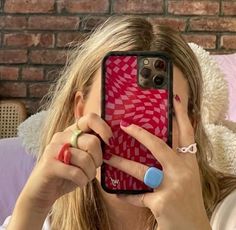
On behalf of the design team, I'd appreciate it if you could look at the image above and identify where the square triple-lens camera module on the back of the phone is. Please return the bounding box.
[138,57,167,89]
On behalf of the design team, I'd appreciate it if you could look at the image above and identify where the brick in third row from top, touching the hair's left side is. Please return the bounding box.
[57,32,86,47]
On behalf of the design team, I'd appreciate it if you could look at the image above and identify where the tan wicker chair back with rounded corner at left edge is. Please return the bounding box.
[0,100,27,138]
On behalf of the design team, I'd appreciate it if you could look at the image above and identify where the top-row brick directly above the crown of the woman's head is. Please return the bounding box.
[113,0,163,13]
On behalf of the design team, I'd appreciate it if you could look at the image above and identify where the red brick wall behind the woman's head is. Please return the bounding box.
[0,0,236,114]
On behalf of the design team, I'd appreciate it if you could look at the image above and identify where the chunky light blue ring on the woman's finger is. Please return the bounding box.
[144,167,163,188]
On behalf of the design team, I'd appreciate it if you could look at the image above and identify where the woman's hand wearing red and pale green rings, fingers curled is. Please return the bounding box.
[14,114,112,214]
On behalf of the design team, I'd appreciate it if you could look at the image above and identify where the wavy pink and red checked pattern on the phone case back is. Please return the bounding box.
[104,56,168,190]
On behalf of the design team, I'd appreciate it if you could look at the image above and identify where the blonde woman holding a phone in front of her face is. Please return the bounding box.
[3,17,236,230]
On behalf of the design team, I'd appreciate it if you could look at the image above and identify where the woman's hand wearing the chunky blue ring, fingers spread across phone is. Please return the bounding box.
[105,97,211,230]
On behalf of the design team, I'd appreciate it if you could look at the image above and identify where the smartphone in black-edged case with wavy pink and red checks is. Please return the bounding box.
[101,51,173,194]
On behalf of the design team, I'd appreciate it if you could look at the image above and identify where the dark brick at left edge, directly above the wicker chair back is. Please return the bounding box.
[0,82,26,97]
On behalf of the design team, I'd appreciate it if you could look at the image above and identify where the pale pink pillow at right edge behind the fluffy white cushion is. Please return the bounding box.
[212,53,236,121]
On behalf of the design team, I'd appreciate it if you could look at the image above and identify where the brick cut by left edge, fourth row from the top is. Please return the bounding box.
[0,50,27,64]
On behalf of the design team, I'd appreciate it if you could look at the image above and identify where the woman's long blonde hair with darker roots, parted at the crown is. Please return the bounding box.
[39,16,236,230]
